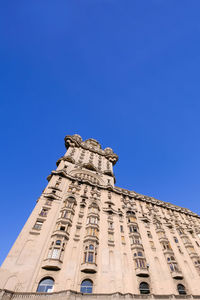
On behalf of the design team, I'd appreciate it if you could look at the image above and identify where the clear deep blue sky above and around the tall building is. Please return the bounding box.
[0,0,200,262]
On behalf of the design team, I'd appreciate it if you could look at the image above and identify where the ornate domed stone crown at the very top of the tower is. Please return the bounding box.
[65,134,118,165]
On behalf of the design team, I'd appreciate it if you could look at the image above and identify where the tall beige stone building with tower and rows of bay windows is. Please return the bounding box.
[0,134,200,300]
